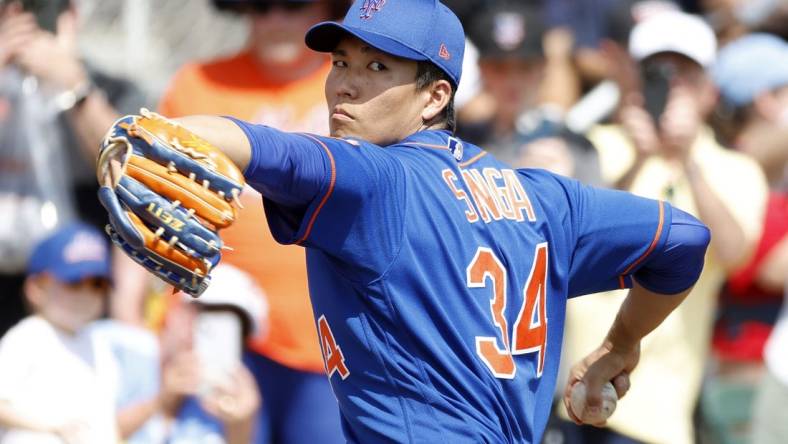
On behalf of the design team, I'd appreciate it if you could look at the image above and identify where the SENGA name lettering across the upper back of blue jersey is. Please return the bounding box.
[441,168,536,223]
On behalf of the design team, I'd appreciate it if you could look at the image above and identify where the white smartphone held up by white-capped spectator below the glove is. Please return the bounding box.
[194,310,243,394]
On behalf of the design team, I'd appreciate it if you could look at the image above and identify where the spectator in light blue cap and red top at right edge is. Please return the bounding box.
[713,34,788,365]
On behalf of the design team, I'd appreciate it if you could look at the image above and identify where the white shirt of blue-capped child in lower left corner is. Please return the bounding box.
[0,316,118,444]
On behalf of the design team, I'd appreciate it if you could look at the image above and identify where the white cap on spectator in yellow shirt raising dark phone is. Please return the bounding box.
[629,11,717,68]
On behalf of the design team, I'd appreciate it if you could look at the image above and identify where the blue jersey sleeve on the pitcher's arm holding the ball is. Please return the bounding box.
[521,170,708,297]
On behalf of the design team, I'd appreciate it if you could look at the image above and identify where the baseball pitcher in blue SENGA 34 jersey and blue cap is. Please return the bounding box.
[101,0,709,443]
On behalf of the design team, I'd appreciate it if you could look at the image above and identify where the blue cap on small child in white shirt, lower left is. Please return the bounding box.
[27,223,110,283]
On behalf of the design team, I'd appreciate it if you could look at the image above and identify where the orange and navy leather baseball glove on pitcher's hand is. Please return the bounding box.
[97,109,244,296]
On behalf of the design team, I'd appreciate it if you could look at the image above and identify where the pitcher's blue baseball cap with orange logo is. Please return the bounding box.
[305,0,465,88]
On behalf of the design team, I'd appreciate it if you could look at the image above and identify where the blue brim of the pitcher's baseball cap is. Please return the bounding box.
[304,22,429,60]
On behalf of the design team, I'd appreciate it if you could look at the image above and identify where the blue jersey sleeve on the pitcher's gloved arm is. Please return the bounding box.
[232,119,405,280]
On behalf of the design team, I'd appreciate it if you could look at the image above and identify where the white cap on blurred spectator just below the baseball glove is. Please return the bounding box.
[183,264,268,334]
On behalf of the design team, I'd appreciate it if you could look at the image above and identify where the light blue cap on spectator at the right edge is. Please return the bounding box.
[711,34,788,106]
